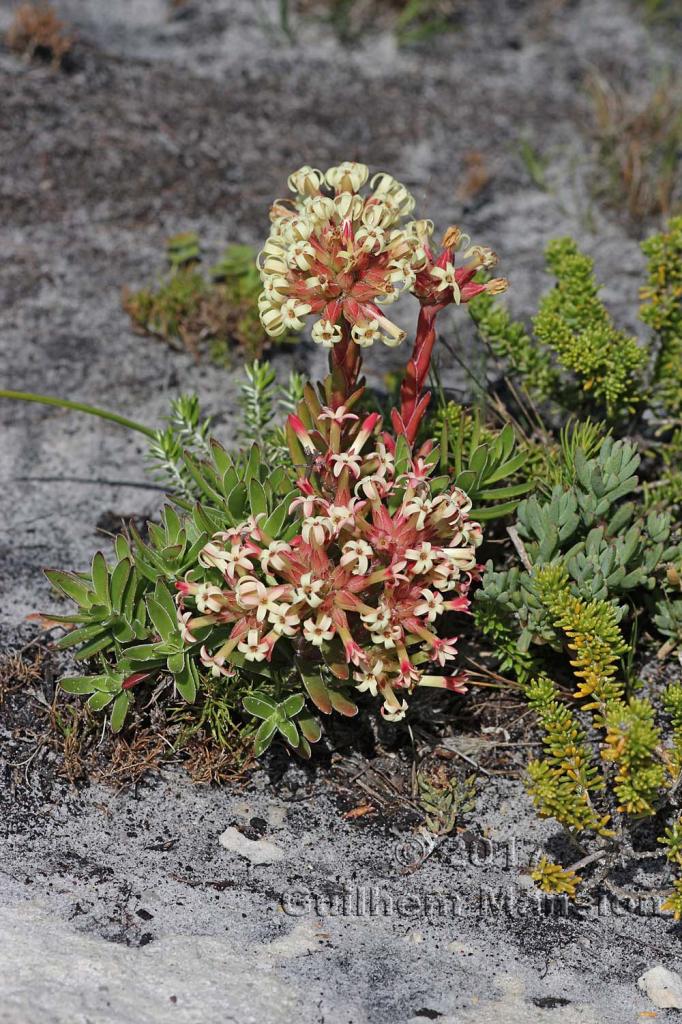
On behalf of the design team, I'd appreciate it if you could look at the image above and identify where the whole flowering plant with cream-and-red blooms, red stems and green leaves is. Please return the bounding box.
[41,157,499,755]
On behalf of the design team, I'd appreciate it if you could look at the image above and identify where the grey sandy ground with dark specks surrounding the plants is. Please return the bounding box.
[0,0,679,1024]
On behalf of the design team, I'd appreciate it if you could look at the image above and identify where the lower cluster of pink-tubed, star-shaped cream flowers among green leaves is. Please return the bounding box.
[177,407,481,721]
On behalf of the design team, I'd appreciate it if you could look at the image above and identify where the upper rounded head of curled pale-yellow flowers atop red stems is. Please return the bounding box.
[254,162,506,348]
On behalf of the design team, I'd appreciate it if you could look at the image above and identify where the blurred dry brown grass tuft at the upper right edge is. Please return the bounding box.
[586,73,682,222]
